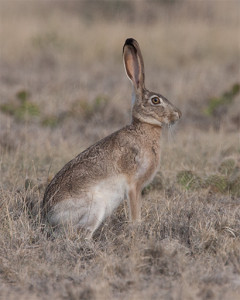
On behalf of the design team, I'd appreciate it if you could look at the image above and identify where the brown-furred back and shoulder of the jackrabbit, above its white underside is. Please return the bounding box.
[43,125,160,216]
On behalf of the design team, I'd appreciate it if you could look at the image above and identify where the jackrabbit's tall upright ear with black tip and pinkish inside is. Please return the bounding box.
[123,38,144,90]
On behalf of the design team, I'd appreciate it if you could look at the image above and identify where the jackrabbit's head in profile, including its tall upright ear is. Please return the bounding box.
[123,38,182,126]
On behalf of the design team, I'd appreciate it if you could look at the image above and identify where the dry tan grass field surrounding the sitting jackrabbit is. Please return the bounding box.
[0,0,240,300]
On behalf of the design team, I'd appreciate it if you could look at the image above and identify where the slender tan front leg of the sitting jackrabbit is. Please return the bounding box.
[128,187,142,223]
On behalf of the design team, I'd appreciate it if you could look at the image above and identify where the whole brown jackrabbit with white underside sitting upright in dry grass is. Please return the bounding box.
[42,38,181,238]
